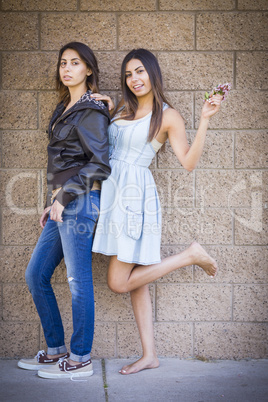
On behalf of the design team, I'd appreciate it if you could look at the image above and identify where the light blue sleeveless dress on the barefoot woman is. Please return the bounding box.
[92,105,167,265]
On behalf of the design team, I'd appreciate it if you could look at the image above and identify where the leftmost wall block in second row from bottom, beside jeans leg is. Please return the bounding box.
[3,283,39,321]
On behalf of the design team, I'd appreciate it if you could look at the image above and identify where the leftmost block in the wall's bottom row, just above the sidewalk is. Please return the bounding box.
[0,321,39,358]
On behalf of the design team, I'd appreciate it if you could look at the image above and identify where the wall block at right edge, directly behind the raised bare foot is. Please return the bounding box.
[194,246,268,284]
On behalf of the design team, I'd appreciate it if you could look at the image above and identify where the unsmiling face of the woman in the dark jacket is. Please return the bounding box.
[59,49,91,89]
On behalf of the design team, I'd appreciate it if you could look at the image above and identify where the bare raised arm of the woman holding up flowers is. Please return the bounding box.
[163,95,222,172]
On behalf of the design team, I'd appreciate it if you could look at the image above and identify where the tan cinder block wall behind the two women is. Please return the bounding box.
[0,0,268,359]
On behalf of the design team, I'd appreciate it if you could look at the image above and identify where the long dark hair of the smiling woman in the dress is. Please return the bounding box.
[114,49,172,141]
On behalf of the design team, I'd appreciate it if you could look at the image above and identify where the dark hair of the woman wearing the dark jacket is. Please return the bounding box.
[56,42,99,106]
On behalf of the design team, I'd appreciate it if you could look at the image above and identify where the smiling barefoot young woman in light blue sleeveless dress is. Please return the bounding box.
[92,49,222,374]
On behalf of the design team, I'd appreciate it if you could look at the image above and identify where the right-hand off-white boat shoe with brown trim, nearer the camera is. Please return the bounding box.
[38,359,93,379]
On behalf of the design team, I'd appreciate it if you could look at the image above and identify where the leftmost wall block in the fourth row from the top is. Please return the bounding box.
[0,91,37,130]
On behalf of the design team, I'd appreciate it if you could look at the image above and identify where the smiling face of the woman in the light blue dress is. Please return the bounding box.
[125,59,152,97]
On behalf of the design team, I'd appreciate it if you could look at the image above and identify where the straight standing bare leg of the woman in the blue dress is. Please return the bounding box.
[119,285,159,375]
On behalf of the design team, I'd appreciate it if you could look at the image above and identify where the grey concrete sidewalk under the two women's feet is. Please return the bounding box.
[0,358,268,402]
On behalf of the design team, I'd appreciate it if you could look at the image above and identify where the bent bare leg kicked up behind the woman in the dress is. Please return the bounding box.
[108,242,217,293]
